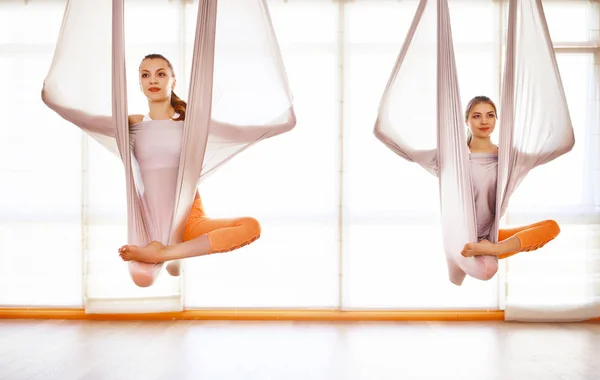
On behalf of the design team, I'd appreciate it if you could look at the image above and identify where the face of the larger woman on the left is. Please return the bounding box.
[140,58,175,101]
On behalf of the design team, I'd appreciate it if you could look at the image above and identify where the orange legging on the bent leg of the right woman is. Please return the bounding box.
[498,220,560,259]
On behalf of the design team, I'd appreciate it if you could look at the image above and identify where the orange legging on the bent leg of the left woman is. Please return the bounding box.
[183,195,260,253]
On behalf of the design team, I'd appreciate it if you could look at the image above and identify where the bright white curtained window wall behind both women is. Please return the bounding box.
[0,0,600,319]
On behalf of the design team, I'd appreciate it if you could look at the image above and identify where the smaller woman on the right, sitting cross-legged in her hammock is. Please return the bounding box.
[374,96,560,280]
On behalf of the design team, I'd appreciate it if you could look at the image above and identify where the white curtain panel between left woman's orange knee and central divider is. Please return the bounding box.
[184,0,339,309]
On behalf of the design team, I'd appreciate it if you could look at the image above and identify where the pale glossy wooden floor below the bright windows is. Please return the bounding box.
[0,320,600,380]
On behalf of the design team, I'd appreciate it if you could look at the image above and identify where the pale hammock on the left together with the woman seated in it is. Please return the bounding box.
[42,0,296,286]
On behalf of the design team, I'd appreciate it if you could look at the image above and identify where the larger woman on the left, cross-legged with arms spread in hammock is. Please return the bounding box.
[42,54,296,287]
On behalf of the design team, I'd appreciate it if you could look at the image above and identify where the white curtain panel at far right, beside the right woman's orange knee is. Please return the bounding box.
[505,0,600,321]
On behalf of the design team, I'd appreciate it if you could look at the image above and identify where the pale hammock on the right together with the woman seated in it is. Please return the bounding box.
[374,0,575,285]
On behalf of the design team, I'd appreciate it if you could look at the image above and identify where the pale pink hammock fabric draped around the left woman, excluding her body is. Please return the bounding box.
[42,0,295,274]
